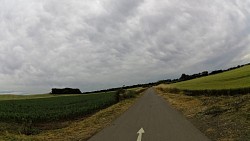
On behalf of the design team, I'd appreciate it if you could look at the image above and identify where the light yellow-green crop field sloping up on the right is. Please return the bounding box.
[170,65,250,90]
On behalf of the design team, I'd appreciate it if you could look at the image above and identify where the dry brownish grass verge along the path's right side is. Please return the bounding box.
[156,85,250,141]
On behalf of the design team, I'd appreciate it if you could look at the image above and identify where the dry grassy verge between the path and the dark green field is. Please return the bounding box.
[0,90,145,141]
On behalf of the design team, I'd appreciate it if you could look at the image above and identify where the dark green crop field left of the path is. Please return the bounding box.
[0,92,117,123]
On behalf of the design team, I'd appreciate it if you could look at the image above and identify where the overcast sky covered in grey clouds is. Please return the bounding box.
[0,0,250,93]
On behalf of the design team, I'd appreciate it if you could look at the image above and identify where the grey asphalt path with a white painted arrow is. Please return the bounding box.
[89,88,209,141]
